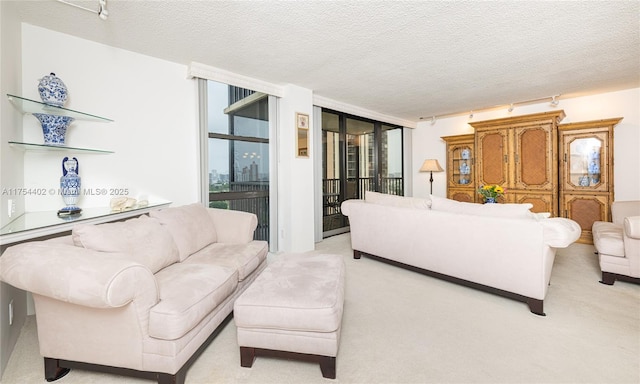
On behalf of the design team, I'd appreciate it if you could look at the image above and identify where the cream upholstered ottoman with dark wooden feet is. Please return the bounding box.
[233,254,345,379]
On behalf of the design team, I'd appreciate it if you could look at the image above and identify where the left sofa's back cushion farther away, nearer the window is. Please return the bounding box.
[149,203,218,261]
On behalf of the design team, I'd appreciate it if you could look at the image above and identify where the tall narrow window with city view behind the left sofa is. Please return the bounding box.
[203,80,269,241]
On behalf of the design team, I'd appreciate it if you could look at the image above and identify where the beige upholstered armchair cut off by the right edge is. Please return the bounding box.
[592,200,640,285]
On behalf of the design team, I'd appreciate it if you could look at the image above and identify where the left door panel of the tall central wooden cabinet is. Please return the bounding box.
[476,130,509,186]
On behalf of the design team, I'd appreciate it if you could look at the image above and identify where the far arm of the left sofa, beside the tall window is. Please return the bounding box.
[207,208,258,244]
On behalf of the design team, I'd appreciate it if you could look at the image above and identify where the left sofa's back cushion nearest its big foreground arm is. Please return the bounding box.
[71,216,178,273]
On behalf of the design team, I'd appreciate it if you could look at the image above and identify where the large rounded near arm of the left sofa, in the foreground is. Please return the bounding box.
[0,241,158,308]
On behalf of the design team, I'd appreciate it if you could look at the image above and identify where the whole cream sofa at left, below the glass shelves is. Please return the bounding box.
[0,204,268,384]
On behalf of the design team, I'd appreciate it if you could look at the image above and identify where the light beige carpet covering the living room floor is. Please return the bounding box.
[2,234,640,384]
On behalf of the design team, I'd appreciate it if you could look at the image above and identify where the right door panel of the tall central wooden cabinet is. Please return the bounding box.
[514,124,557,190]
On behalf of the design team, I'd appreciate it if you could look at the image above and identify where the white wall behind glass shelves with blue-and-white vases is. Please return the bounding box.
[19,24,199,211]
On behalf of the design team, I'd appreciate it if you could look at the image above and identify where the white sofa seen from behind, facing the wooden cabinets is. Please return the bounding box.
[341,192,581,315]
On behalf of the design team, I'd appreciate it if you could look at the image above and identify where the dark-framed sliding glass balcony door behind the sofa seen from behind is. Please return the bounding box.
[322,109,404,237]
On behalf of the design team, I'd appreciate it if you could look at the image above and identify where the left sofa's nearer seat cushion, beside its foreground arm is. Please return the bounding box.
[149,263,238,340]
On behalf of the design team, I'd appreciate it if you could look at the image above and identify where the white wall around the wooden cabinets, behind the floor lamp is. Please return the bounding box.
[412,88,640,200]
